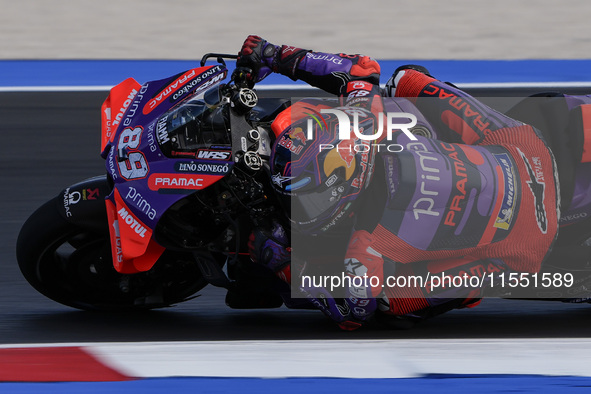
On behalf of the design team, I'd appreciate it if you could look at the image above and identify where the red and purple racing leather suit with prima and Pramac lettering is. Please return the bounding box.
[242,37,559,329]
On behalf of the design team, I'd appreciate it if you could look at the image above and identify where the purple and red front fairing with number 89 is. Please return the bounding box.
[102,65,233,273]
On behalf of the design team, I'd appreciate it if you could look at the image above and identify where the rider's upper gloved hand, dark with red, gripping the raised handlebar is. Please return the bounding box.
[236,35,277,87]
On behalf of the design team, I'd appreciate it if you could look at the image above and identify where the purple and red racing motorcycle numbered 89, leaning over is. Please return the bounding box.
[17,54,591,311]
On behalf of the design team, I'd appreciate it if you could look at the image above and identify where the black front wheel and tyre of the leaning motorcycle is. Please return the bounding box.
[16,196,207,311]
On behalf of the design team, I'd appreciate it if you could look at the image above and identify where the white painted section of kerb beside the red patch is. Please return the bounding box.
[0,338,591,378]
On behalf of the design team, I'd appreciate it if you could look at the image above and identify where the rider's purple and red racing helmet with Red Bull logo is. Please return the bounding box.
[270,103,375,235]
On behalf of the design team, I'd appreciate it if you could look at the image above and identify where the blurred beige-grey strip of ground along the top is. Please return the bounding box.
[0,0,591,59]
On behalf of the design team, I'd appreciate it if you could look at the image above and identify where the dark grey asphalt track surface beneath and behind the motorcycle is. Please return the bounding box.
[0,91,591,344]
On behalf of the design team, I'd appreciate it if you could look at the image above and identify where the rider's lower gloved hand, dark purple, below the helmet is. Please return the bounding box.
[248,223,291,282]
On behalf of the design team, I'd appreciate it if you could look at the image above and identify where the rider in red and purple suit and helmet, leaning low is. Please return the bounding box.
[236,36,560,329]
